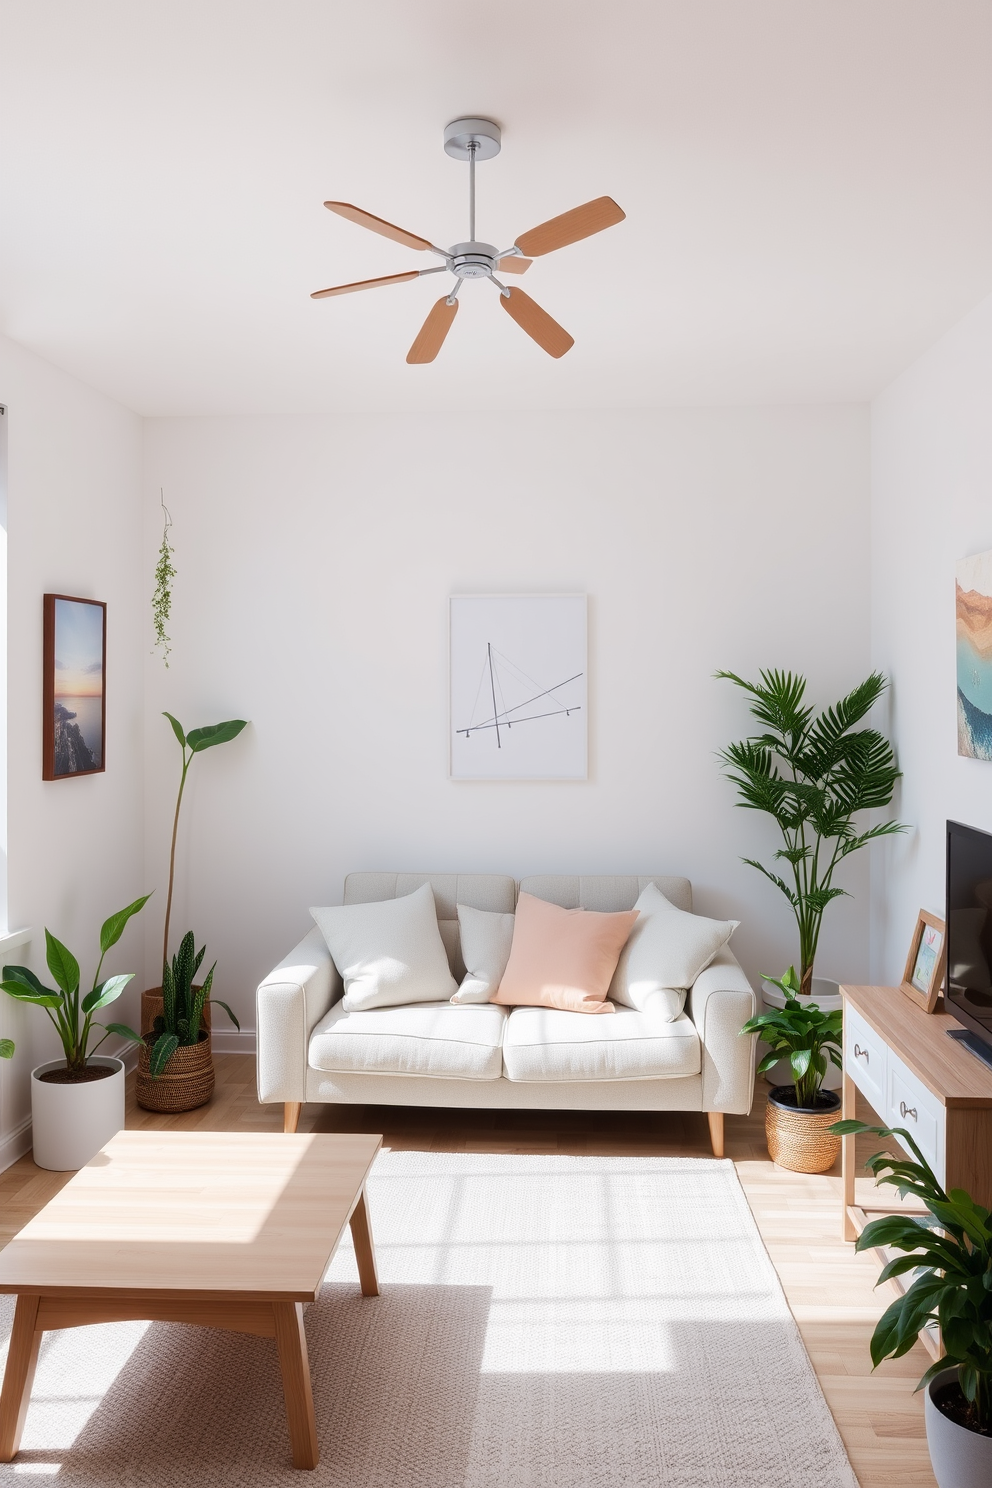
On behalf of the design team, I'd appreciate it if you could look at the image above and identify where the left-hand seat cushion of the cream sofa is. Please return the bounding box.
[309,1001,507,1080]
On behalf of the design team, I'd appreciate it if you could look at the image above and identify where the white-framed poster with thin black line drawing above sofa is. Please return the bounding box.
[449,594,589,780]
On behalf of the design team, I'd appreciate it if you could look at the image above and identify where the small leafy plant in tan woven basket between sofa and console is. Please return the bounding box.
[741,966,843,1173]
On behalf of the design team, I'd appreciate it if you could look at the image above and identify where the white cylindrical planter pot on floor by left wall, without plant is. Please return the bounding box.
[31,1055,123,1173]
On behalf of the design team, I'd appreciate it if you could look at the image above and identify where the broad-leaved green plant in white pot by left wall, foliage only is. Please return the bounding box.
[0,894,152,1079]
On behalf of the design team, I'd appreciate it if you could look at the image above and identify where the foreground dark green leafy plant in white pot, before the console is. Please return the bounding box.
[833,1120,992,1488]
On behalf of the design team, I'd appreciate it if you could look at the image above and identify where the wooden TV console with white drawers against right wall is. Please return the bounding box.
[840,987,992,1240]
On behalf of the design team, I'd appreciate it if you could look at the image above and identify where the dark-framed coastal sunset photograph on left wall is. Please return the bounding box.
[42,594,107,780]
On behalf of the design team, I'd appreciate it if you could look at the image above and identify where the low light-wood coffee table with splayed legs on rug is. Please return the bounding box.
[0,1131,382,1467]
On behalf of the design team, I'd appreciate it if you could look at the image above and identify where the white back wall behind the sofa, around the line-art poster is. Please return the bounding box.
[144,408,869,1027]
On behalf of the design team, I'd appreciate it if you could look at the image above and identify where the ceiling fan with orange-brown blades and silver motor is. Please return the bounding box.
[311,119,626,363]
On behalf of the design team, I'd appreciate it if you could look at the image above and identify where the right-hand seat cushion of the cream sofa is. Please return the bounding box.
[503,1007,700,1082]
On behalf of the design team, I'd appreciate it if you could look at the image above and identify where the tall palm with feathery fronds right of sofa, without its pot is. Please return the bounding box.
[717,671,906,997]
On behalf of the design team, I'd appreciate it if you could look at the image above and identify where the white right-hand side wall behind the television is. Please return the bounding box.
[872,299,992,982]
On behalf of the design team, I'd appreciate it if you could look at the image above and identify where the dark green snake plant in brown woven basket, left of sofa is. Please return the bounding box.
[135,930,241,1112]
